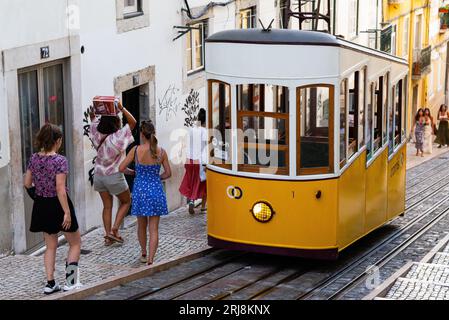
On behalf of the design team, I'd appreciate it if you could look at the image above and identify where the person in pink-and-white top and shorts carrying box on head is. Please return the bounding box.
[90,102,137,246]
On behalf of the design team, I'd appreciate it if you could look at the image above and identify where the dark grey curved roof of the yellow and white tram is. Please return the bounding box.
[206,29,407,64]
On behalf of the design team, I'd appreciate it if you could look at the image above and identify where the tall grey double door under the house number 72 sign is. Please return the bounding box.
[18,62,71,250]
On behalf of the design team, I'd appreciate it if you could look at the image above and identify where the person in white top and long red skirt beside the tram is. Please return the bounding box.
[179,109,207,214]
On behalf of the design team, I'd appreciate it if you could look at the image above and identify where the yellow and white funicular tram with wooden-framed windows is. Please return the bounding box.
[206,29,408,259]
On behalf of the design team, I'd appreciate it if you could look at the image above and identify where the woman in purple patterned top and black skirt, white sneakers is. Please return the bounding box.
[25,124,81,294]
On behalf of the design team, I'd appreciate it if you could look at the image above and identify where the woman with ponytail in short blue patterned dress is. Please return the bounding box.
[120,121,171,265]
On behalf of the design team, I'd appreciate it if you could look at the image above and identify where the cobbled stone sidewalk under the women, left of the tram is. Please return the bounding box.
[0,208,208,300]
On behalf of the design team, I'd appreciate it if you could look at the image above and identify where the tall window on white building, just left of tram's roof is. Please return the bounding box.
[186,21,207,73]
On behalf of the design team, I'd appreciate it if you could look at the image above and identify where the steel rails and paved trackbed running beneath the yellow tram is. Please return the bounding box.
[80,154,449,300]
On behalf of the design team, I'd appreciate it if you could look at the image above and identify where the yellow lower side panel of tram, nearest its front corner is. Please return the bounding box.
[337,152,366,250]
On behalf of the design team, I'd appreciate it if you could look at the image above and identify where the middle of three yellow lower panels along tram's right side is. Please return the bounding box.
[365,148,388,234]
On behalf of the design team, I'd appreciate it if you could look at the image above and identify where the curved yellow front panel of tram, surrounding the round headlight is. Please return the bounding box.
[207,169,338,250]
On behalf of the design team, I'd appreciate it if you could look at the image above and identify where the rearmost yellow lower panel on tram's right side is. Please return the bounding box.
[388,144,407,219]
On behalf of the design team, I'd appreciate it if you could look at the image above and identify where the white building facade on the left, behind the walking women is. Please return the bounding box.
[0,0,288,253]
